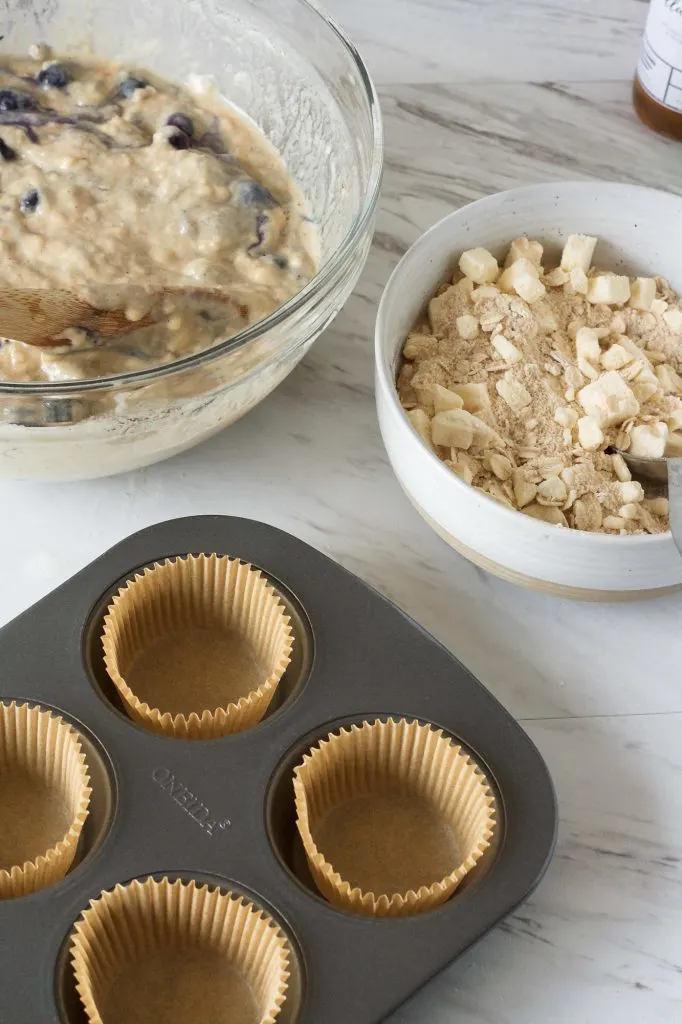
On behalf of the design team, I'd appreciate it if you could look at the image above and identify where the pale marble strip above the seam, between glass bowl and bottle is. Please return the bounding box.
[323,0,646,83]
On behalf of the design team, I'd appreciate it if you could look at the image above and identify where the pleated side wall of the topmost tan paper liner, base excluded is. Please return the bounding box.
[102,554,294,739]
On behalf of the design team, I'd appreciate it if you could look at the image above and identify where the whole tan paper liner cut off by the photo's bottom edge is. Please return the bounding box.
[72,879,289,1024]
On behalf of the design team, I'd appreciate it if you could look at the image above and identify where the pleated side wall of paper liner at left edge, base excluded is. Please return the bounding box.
[0,701,92,899]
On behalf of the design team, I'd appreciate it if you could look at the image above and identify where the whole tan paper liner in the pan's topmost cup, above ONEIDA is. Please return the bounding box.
[102,555,294,739]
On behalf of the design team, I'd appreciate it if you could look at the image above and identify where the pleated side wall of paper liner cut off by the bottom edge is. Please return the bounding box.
[71,878,290,1024]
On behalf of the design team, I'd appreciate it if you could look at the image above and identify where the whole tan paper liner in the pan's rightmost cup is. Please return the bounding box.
[294,719,495,918]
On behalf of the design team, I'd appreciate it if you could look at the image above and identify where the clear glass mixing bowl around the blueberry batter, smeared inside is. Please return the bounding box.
[0,0,383,479]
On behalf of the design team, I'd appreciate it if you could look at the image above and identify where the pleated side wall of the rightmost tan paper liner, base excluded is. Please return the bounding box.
[294,719,495,918]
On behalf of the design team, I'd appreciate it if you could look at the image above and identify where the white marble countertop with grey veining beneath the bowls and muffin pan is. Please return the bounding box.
[0,0,682,1024]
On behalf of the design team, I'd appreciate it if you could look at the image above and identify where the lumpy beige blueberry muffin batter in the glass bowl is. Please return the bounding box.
[0,50,316,381]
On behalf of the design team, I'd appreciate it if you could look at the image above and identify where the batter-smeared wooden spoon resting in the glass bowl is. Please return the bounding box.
[0,287,236,348]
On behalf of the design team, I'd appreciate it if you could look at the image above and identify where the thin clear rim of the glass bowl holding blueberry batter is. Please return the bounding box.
[0,0,384,397]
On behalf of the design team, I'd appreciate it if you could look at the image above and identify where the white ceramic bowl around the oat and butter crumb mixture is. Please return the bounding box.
[376,182,682,600]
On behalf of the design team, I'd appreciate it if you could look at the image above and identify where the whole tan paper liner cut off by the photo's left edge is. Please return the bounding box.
[0,701,91,899]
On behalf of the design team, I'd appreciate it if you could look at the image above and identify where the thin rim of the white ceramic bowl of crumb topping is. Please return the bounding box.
[375,179,682,546]
